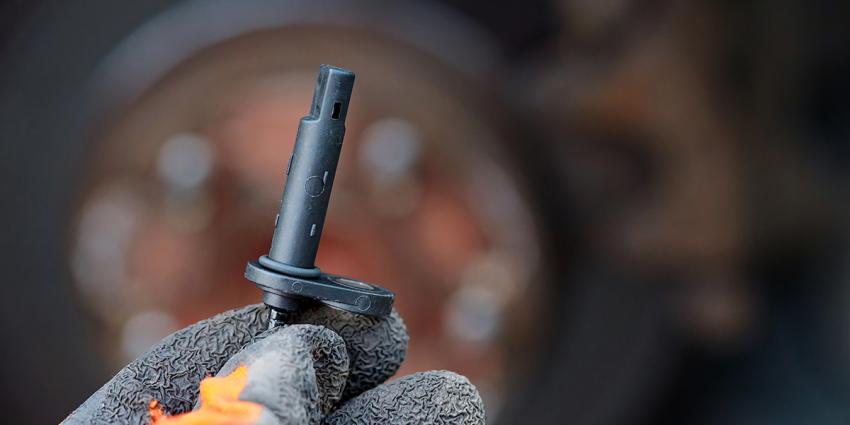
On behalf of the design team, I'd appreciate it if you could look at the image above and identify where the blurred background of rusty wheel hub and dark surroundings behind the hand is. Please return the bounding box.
[0,0,850,425]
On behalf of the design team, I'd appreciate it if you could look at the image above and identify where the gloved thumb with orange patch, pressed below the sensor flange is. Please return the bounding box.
[153,325,349,425]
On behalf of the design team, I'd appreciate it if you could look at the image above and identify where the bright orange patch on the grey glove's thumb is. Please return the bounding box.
[149,366,262,425]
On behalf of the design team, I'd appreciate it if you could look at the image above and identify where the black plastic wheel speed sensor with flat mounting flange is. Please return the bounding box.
[245,65,395,326]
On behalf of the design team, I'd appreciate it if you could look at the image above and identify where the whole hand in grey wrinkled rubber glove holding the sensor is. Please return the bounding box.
[63,305,484,425]
